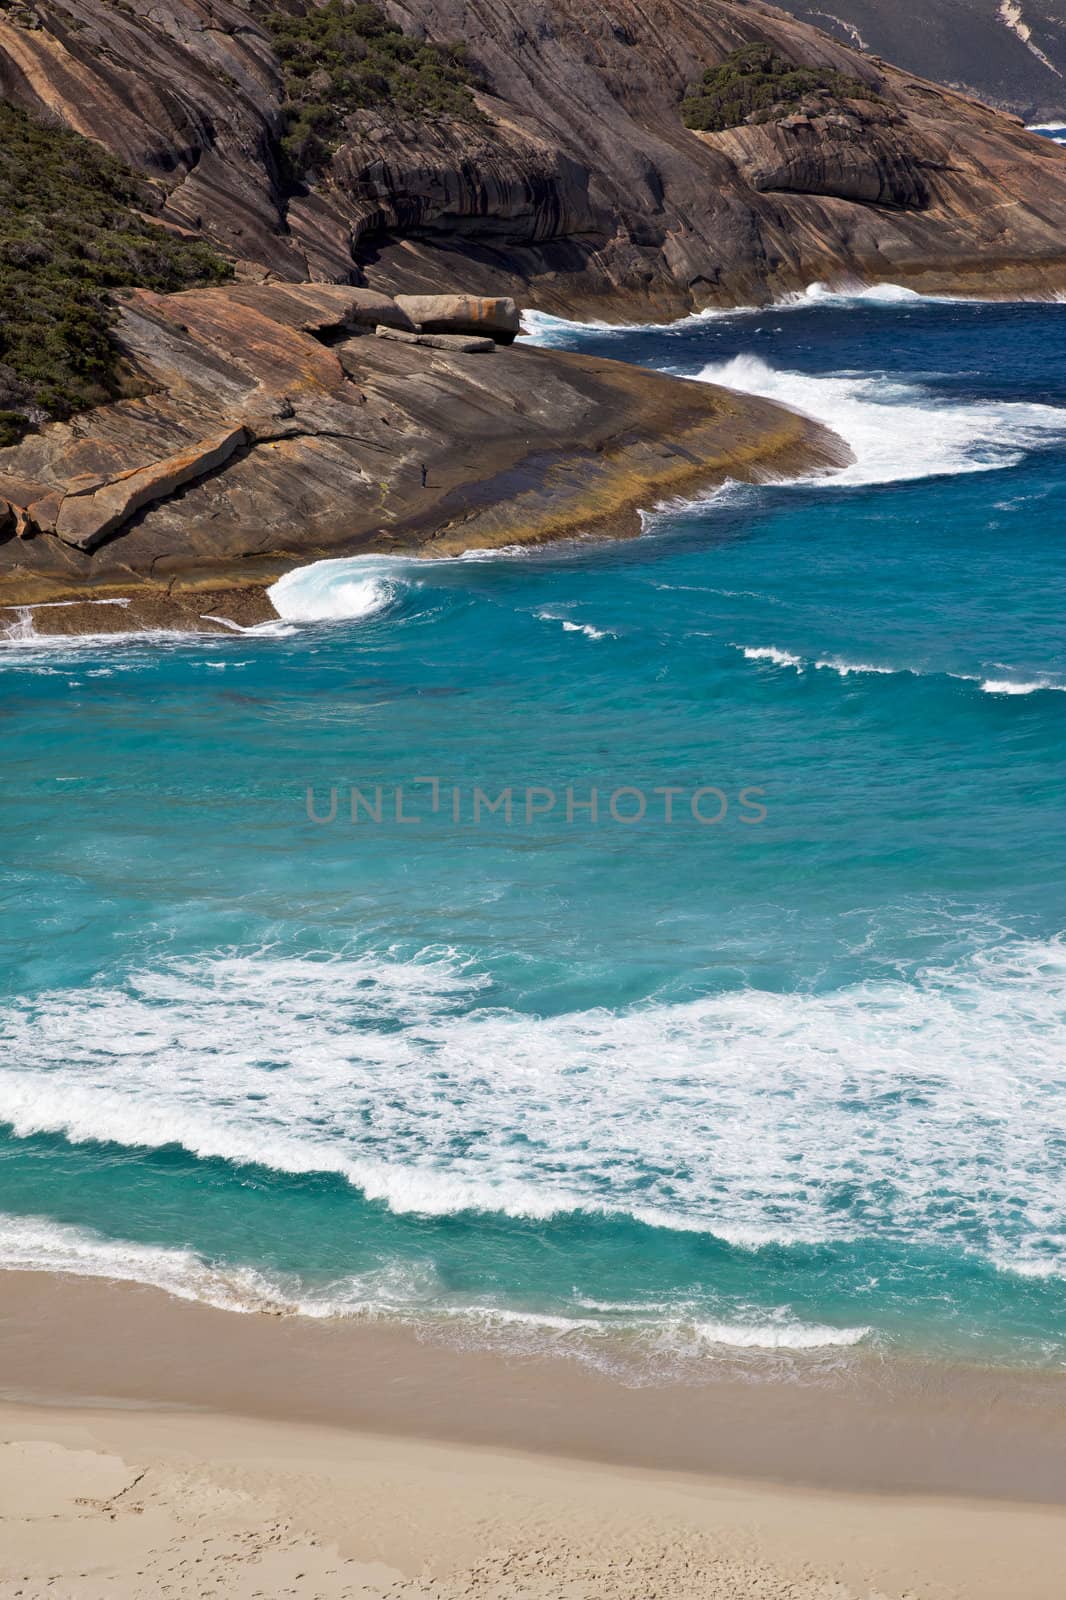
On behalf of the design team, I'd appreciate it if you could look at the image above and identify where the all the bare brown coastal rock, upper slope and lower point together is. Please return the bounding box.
[0,0,1066,627]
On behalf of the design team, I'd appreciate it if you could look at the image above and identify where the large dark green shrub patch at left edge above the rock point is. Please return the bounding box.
[0,101,232,445]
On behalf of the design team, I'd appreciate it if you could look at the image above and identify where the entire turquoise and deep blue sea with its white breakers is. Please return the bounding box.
[0,290,1066,1376]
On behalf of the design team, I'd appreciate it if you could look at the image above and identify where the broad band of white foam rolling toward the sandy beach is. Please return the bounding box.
[0,941,1066,1248]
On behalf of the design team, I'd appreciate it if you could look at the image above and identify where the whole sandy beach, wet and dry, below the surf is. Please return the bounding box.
[0,1272,1066,1600]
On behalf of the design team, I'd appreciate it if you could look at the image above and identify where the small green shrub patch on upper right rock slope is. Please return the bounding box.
[682,45,879,133]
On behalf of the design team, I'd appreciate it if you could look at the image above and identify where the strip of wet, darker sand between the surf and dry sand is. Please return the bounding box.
[0,1270,1066,1506]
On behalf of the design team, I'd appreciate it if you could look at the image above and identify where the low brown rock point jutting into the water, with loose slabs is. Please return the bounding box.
[0,285,847,627]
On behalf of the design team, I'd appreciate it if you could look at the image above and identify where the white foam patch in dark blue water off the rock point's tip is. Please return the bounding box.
[696,355,1066,488]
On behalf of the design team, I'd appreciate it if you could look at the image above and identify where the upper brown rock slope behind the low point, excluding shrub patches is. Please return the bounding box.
[0,0,1066,315]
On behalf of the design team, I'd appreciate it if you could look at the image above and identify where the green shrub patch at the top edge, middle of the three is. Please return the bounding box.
[262,0,485,182]
